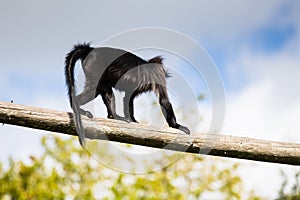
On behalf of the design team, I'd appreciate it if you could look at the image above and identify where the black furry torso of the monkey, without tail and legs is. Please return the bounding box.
[83,47,166,93]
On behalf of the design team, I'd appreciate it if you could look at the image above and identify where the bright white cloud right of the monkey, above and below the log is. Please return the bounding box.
[223,14,300,199]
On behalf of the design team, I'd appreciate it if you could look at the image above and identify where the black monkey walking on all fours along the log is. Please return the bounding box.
[65,43,190,146]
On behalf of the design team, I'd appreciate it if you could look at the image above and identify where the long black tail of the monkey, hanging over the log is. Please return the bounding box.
[65,43,93,147]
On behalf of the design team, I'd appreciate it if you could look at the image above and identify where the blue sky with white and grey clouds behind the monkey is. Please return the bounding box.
[0,0,300,198]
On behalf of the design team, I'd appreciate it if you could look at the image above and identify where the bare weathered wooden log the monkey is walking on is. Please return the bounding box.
[0,102,300,165]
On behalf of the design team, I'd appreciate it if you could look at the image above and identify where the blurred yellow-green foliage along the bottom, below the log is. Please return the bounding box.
[0,136,259,200]
